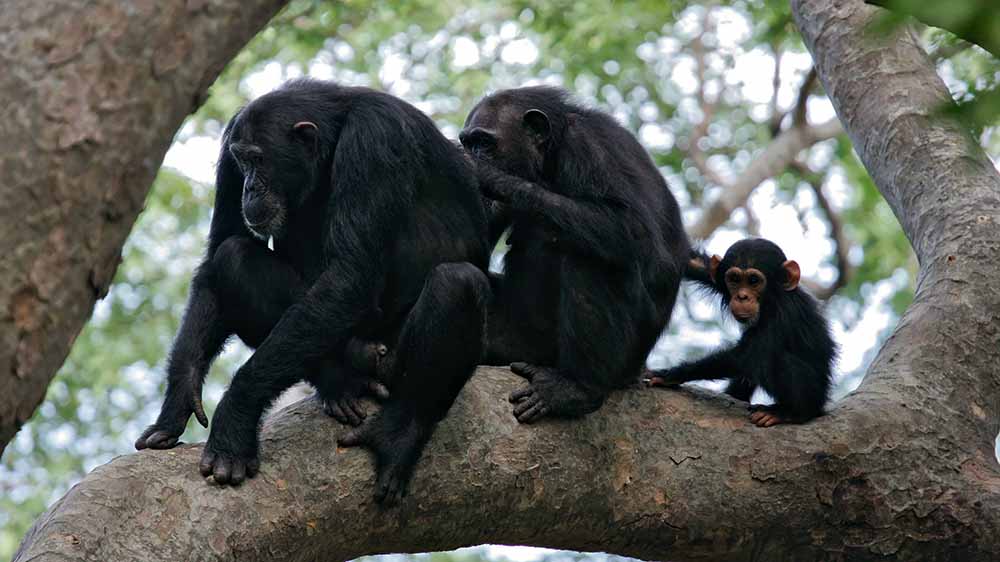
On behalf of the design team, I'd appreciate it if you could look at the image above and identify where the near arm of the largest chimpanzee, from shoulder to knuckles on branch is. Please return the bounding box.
[201,107,419,483]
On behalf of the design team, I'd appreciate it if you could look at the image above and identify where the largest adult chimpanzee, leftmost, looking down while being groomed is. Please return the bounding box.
[136,76,489,501]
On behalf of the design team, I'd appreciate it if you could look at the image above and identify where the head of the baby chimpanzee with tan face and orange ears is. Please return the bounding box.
[708,239,800,326]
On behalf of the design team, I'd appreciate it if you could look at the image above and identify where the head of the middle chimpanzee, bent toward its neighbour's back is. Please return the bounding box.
[458,96,551,181]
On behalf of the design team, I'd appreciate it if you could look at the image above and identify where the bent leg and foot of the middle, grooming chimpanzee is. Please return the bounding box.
[510,257,662,423]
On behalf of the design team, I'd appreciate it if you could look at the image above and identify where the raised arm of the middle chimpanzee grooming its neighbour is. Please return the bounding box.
[478,163,651,265]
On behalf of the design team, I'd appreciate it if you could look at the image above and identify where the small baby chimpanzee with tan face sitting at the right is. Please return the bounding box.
[649,238,837,427]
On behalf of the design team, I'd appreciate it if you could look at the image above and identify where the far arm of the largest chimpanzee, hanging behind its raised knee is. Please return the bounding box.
[135,120,253,449]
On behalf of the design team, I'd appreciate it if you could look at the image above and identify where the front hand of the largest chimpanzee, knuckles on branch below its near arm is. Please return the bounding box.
[198,378,260,486]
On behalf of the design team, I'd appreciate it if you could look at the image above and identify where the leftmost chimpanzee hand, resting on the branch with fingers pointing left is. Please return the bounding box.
[135,366,208,451]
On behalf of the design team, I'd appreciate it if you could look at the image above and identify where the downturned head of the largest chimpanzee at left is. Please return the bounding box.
[228,107,317,238]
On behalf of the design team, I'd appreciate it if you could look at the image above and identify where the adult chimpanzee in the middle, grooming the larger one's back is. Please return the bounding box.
[459,87,690,423]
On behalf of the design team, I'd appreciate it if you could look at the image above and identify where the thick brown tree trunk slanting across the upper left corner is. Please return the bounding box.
[0,0,284,452]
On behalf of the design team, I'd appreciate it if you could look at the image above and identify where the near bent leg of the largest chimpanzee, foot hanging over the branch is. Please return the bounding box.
[340,263,490,505]
